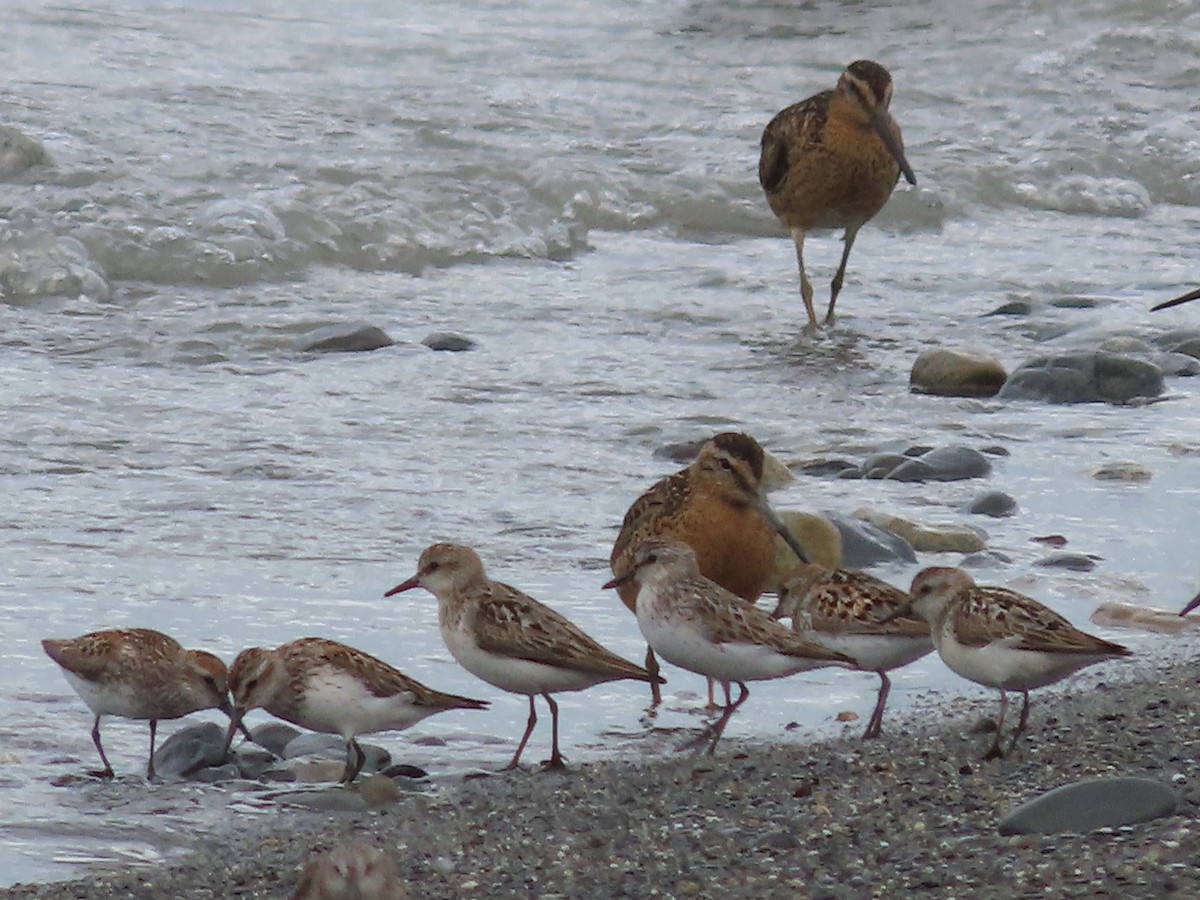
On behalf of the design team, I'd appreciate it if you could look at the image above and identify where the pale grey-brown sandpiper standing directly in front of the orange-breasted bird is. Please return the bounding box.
[604,538,853,754]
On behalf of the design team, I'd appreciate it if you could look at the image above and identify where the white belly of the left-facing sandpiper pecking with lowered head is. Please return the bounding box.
[286,670,438,738]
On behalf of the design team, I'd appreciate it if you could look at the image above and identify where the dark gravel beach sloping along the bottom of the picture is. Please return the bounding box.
[0,660,1200,898]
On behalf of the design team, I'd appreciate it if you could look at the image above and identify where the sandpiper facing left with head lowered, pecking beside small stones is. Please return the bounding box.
[226,637,487,785]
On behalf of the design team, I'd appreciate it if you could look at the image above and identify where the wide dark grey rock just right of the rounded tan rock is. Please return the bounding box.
[1000,352,1163,403]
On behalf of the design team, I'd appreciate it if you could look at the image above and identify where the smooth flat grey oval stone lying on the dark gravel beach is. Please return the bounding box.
[996,775,1180,834]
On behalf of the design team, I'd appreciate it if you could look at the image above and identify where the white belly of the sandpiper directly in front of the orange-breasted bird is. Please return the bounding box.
[637,609,811,682]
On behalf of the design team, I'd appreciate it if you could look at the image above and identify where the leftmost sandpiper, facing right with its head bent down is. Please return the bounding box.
[42,628,232,779]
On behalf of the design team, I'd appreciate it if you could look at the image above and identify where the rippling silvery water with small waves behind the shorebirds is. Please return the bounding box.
[0,0,1200,883]
